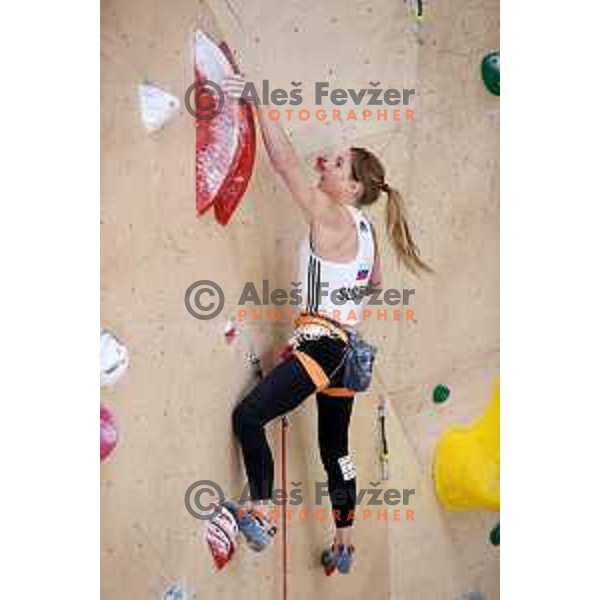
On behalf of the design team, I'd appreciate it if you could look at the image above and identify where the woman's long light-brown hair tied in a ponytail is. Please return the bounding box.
[352,148,433,274]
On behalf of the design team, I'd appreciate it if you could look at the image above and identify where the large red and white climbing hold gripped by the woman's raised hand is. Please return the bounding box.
[194,31,256,225]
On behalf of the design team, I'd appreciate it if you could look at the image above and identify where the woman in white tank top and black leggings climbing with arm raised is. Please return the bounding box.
[213,75,430,573]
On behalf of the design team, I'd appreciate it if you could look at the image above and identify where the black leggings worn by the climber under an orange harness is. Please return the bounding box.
[233,338,356,528]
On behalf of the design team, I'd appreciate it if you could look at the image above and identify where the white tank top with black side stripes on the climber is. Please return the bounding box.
[298,205,375,325]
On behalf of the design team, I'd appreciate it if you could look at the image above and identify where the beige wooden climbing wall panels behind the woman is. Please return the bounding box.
[100,0,499,600]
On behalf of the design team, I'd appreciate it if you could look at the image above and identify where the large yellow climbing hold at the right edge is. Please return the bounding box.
[433,378,500,511]
